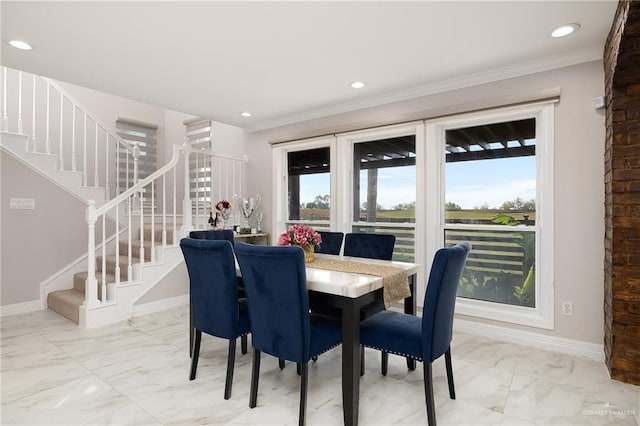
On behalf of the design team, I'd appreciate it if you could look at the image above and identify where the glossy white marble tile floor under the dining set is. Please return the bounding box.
[0,306,640,426]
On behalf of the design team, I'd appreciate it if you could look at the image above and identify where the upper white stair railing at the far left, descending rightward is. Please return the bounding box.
[1,67,138,200]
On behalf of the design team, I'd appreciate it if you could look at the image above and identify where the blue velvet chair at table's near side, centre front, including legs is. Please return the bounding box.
[235,243,342,425]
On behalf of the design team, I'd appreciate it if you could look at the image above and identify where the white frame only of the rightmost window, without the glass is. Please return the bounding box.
[424,101,555,329]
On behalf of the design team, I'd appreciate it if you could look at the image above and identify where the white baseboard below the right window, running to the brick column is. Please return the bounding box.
[453,318,604,361]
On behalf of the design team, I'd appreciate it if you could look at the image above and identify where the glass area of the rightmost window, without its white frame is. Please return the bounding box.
[445,118,536,307]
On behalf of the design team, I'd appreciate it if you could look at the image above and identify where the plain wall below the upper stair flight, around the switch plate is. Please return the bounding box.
[0,151,87,306]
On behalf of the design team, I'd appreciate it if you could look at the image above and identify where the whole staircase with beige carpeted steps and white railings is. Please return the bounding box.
[0,67,247,327]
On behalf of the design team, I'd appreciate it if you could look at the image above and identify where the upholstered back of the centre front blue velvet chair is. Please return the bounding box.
[235,243,311,363]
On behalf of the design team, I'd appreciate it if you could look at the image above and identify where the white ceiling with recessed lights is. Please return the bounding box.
[0,0,617,131]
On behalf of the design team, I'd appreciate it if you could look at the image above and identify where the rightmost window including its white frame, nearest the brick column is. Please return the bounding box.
[427,105,553,328]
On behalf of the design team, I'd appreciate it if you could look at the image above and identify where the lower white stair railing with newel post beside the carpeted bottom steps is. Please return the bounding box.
[84,142,247,309]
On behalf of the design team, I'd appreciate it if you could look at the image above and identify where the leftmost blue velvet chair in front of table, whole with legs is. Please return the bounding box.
[180,238,251,399]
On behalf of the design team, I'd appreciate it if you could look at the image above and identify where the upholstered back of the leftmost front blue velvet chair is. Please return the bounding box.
[180,238,244,339]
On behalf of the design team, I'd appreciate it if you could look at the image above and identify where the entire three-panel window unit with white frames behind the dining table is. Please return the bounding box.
[273,105,554,329]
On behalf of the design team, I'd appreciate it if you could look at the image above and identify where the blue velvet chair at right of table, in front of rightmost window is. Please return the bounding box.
[360,242,471,426]
